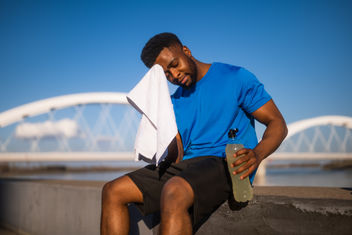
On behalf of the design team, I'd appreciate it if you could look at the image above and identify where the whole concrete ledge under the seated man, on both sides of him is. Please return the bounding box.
[0,179,352,235]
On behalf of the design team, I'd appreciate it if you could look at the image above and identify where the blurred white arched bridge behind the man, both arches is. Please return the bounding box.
[0,92,352,162]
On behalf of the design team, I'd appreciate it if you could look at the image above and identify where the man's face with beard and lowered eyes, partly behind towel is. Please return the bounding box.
[154,45,197,88]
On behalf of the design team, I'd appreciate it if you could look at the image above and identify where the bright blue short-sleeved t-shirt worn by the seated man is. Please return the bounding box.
[171,63,271,180]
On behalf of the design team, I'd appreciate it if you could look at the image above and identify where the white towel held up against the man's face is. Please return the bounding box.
[127,64,177,165]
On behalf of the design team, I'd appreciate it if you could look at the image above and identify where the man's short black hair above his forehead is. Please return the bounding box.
[141,33,182,68]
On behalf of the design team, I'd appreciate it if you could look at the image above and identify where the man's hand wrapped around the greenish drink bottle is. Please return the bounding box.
[232,148,261,180]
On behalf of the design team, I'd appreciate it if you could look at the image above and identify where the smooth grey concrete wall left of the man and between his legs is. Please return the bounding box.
[0,180,155,235]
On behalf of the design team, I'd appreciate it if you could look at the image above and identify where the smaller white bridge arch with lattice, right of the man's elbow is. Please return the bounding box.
[274,116,352,160]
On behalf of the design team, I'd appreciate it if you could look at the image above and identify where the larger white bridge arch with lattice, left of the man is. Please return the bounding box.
[0,92,140,162]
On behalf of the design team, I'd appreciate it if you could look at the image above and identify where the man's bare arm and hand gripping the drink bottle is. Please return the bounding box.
[233,100,287,179]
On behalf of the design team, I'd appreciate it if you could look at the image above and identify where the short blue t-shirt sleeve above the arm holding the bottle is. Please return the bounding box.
[238,68,271,113]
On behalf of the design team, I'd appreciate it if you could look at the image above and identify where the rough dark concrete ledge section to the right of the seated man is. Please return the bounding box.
[197,187,352,235]
